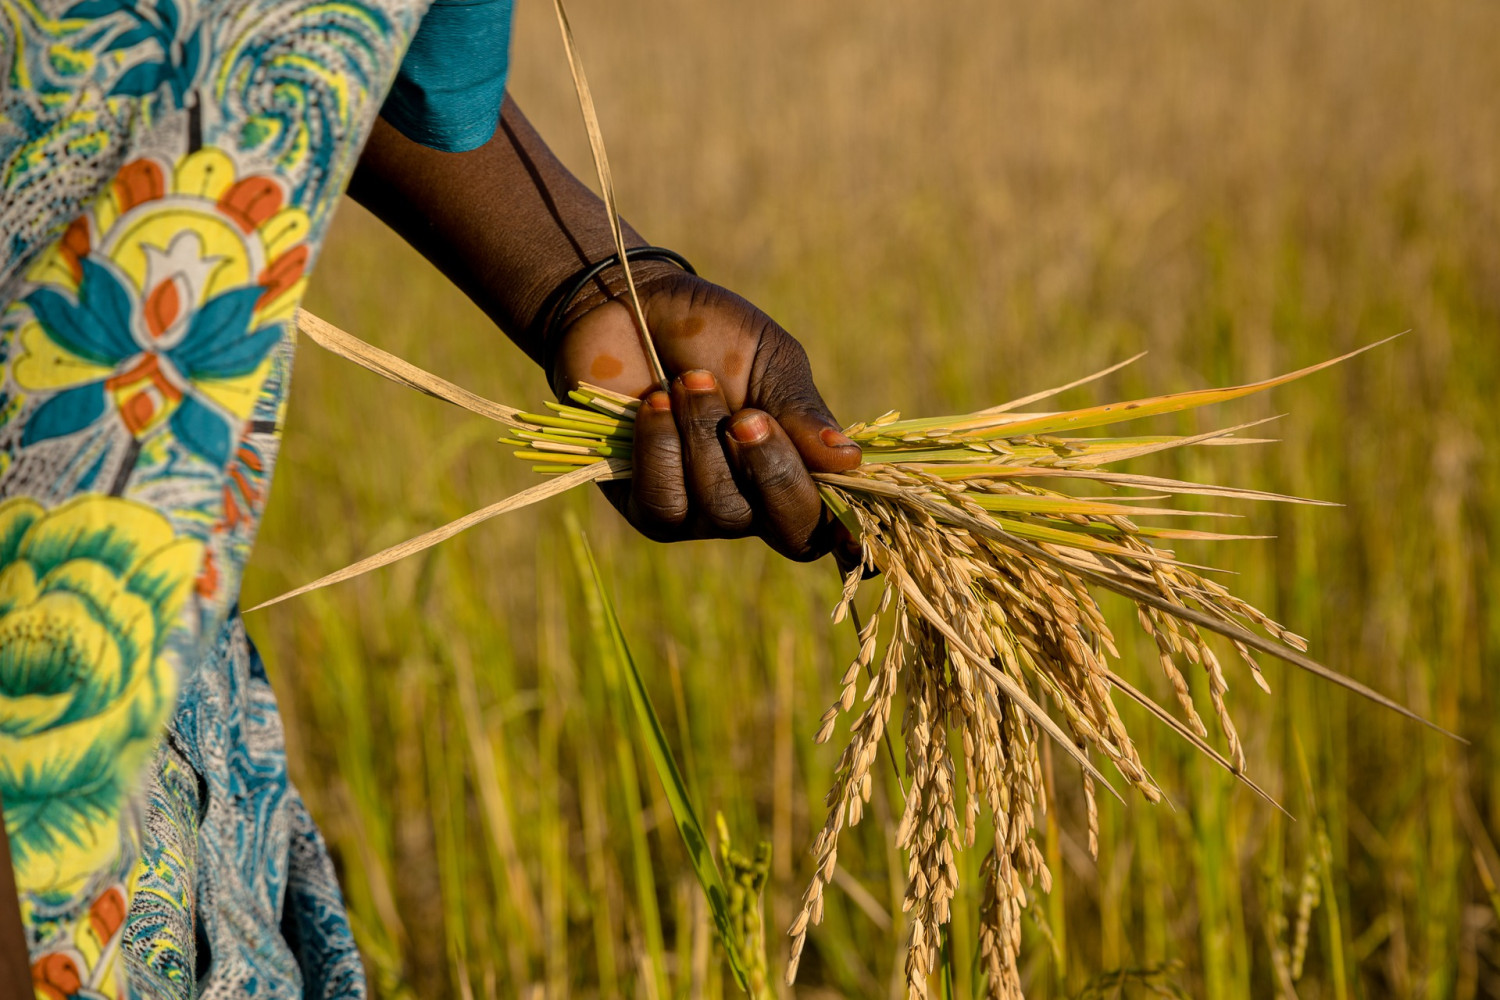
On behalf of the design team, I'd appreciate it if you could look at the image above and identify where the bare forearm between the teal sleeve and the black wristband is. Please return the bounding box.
[350,97,660,361]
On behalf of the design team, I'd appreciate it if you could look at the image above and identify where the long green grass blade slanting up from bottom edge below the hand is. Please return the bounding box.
[579,532,750,993]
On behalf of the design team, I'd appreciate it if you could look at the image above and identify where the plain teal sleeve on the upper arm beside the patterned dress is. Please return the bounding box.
[381,0,515,153]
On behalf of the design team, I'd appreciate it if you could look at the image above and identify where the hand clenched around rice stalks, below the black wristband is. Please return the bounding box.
[551,267,860,559]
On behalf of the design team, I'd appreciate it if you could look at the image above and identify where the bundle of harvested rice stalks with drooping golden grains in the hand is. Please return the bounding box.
[489,345,1428,999]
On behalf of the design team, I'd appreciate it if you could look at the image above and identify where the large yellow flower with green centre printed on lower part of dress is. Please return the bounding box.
[0,495,203,895]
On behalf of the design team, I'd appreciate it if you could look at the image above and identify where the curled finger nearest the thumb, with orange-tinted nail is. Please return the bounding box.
[725,409,828,559]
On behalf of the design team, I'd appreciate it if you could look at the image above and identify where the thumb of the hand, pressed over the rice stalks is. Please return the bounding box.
[752,325,861,472]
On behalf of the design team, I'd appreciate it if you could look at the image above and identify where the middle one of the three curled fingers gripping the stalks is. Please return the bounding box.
[675,370,755,537]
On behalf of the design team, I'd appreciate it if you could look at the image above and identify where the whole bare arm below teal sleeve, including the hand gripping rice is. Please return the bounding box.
[350,97,860,558]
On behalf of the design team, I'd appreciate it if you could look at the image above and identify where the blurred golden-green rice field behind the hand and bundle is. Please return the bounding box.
[245,0,1500,1000]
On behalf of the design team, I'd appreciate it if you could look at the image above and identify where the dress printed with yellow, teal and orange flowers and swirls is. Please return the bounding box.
[0,0,509,1000]
